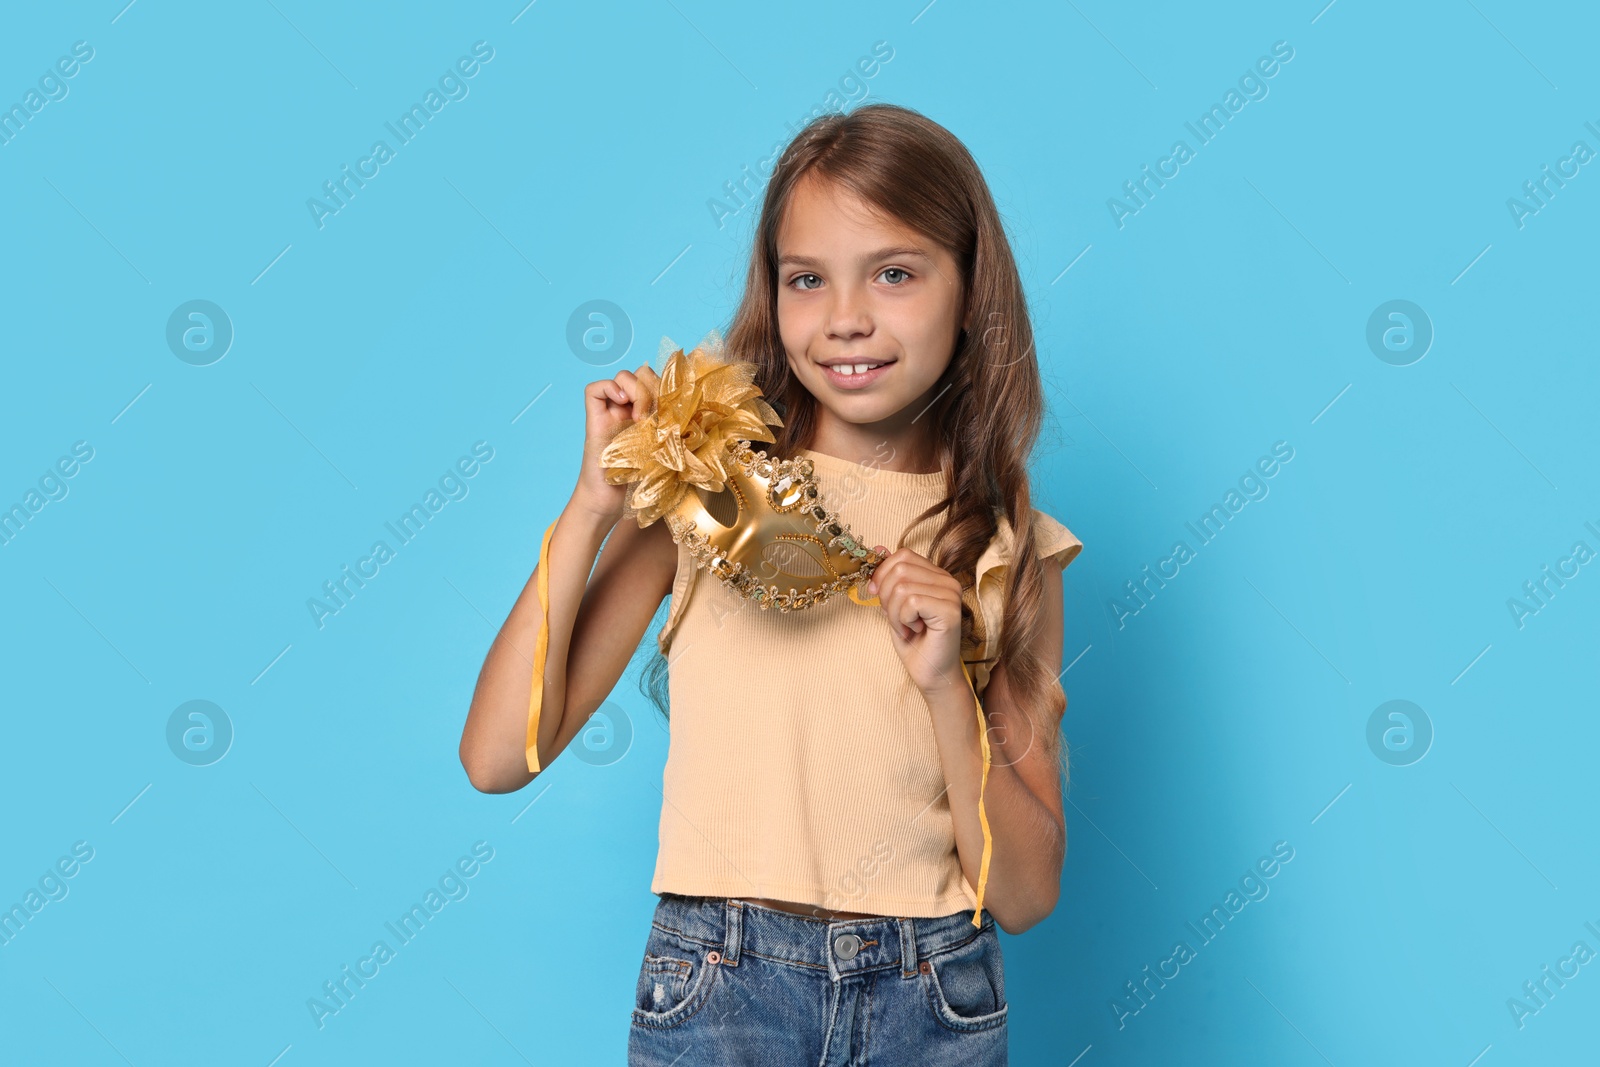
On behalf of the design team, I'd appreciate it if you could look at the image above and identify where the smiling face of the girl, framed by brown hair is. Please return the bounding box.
[778,174,962,438]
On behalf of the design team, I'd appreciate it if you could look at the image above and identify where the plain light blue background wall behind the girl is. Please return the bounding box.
[0,0,1600,1067]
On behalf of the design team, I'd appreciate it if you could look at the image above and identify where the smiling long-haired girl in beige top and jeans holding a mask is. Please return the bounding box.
[461,104,1082,1067]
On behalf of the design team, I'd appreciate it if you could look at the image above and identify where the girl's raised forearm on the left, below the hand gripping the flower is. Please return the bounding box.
[461,496,616,793]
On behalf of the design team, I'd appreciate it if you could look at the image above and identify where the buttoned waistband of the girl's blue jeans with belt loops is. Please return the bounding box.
[653,893,994,977]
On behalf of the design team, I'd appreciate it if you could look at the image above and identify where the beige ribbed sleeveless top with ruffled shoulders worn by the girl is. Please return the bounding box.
[650,450,1082,917]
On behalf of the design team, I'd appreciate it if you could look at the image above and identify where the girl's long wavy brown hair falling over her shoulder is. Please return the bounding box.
[642,104,1066,771]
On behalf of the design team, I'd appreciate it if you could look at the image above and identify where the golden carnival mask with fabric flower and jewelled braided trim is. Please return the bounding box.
[600,331,885,611]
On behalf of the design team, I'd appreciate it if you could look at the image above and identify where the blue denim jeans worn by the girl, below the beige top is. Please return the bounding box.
[627,893,1008,1067]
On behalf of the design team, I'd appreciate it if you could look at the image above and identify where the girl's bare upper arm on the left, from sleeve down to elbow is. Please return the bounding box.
[552,515,678,758]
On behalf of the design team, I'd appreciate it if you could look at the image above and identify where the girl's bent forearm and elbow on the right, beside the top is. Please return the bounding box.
[926,677,1066,934]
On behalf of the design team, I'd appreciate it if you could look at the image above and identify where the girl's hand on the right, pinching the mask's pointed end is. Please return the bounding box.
[866,545,965,694]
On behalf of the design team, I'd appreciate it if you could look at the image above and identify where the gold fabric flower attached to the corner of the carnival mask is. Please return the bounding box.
[600,331,782,528]
